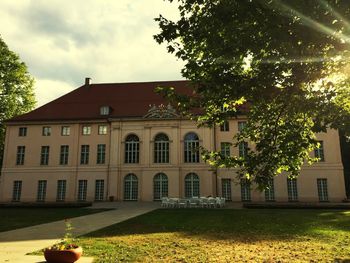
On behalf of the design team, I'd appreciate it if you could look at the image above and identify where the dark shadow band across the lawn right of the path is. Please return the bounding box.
[84,209,350,242]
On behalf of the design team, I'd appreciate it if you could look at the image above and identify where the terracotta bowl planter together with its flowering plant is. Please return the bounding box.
[44,219,83,263]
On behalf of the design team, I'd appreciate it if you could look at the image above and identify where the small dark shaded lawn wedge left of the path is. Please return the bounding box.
[0,207,106,232]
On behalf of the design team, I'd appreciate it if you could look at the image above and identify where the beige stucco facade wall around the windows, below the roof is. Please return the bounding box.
[0,119,345,202]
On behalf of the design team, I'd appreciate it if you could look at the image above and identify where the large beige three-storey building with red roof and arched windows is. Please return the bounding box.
[0,79,346,202]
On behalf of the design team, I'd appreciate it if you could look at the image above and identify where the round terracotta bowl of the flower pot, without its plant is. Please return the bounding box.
[44,247,83,263]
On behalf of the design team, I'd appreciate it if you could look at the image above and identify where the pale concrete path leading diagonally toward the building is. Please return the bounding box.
[0,202,160,263]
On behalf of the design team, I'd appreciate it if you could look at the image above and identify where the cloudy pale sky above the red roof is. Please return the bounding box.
[0,0,183,106]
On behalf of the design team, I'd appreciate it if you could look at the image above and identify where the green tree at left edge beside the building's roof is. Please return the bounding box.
[0,37,35,168]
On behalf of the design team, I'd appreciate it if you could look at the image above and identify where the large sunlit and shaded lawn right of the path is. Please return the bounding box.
[80,209,350,262]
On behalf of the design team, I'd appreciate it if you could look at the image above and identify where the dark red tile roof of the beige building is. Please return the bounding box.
[7,80,191,122]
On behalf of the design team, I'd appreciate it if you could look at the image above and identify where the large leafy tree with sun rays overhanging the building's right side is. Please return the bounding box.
[155,0,350,189]
